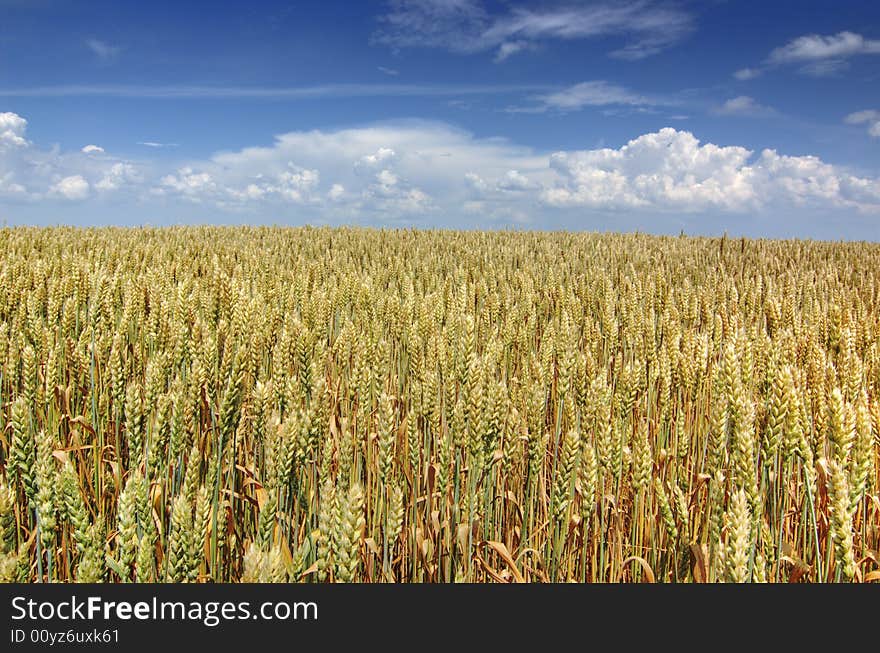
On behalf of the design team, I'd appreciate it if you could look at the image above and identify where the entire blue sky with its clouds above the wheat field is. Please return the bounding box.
[0,0,880,240]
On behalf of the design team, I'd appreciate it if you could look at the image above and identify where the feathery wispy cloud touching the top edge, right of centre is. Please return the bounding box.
[373,0,693,62]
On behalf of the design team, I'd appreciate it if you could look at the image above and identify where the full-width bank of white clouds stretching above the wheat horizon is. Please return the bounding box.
[0,111,880,226]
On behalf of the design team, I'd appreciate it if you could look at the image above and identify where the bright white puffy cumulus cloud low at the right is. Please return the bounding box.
[542,128,880,212]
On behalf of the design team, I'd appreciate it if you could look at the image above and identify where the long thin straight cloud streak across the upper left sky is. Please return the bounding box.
[0,84,554,100]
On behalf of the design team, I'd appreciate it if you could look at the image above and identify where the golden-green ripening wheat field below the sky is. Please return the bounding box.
[0,227,880,583]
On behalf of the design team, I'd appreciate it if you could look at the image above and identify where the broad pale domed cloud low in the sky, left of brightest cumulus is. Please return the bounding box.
[147,121,552,220]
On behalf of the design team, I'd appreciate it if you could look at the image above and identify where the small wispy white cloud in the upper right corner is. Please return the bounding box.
[734,31,880,80]
